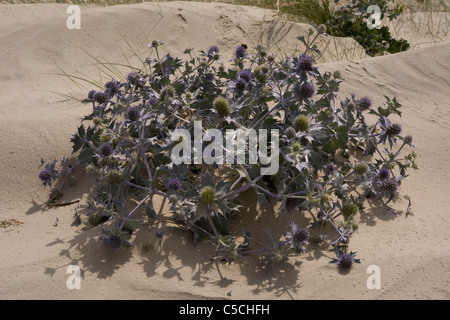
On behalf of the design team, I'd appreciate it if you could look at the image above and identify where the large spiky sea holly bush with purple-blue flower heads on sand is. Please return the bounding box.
[39,26,417,268]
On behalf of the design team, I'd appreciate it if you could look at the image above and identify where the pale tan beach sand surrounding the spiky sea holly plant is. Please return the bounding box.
[0,2,450,300]
